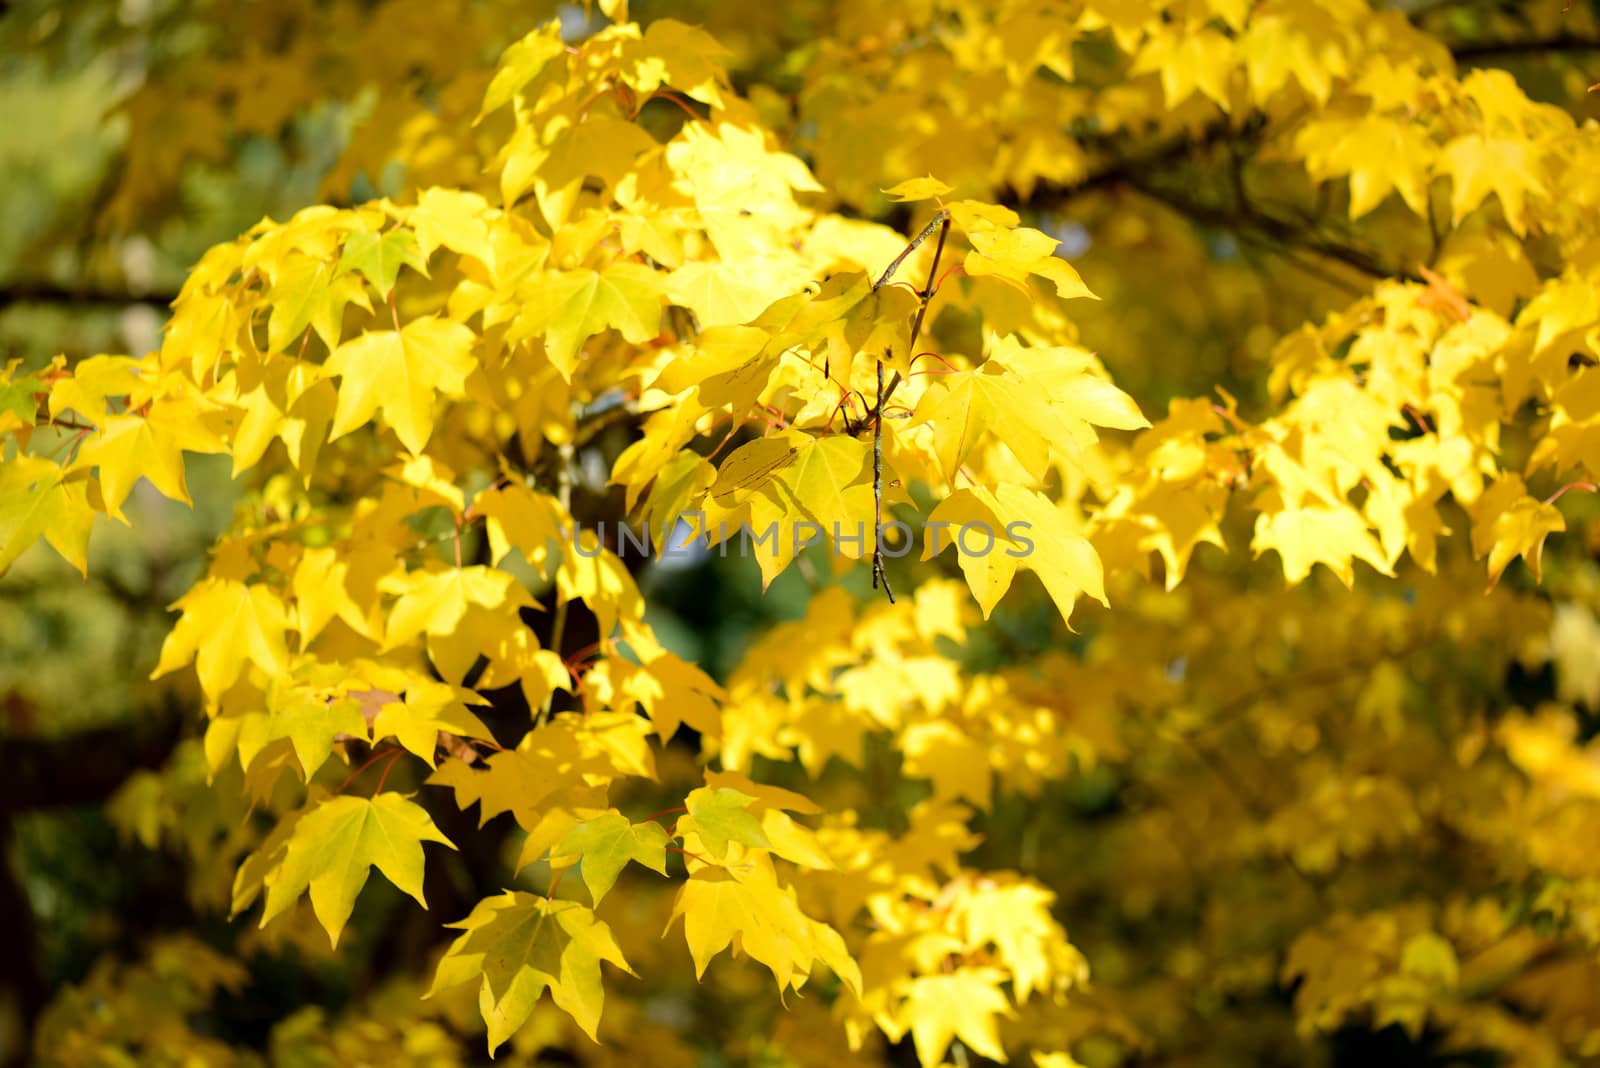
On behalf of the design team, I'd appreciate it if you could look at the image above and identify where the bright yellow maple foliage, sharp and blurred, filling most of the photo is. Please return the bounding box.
[9,0,1600,1068]
